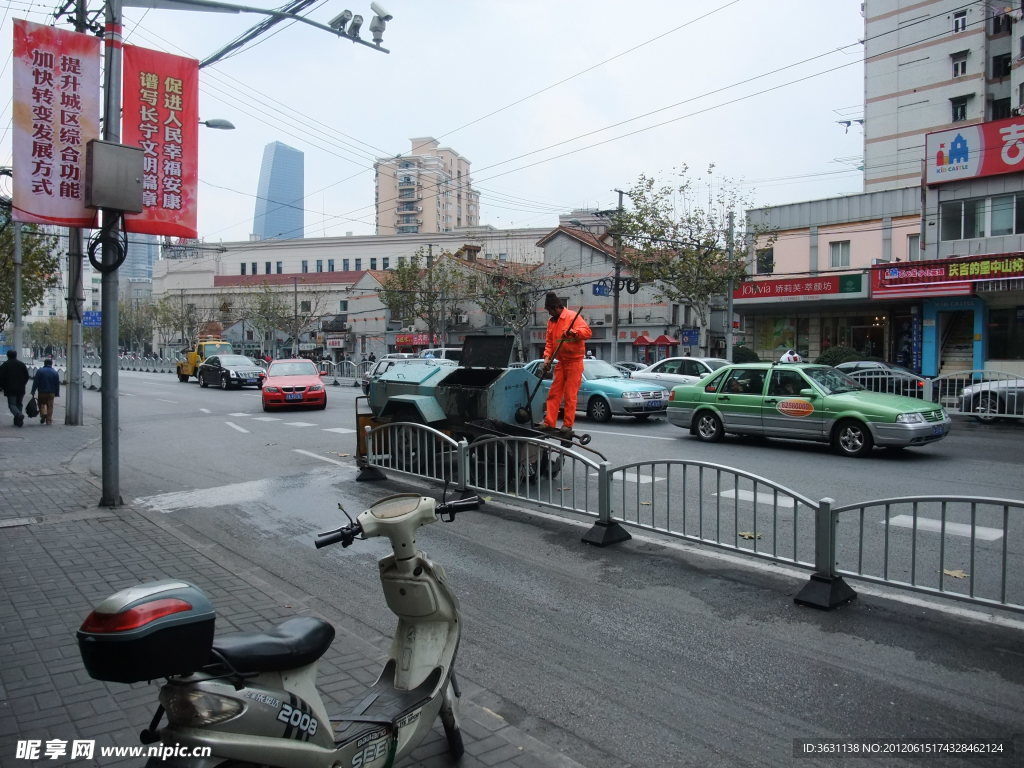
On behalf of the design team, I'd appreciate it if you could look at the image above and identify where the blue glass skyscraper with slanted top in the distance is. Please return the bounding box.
[252,141,305,240]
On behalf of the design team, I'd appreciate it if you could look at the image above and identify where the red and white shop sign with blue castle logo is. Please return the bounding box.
[925,118,1024,184]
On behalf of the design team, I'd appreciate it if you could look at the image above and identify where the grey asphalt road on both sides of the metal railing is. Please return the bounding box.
[74,373,1024,768]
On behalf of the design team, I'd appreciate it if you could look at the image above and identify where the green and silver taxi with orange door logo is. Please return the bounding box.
[668,362,950,457]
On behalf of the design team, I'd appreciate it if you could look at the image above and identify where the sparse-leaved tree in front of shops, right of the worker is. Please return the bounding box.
[613,166,774,351]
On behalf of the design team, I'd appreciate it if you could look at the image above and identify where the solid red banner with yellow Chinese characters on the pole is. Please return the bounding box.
[121,45,199,238]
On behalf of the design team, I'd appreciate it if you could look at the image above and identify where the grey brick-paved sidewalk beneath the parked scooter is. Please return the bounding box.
[0,421,577,768]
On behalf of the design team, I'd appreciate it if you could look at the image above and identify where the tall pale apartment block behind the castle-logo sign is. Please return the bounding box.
[862,0,1024,193]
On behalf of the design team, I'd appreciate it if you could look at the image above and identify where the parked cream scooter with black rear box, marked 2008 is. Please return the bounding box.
[78,494,479,768]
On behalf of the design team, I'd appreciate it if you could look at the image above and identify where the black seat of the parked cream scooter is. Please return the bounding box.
[212,616,334,673]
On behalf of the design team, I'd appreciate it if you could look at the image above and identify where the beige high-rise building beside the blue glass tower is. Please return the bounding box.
[374,137,480,234]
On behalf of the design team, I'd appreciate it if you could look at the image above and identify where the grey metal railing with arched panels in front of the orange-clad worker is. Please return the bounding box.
[360,422,1024,612]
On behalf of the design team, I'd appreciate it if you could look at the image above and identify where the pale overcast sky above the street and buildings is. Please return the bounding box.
[0,0,863,242]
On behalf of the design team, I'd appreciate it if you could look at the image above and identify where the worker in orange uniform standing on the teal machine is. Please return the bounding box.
[539,291,594,436]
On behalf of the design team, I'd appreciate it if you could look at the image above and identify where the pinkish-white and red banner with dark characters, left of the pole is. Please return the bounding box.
[11,18,99,226]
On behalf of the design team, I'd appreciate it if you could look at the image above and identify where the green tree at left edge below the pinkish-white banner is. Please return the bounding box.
[0,211,60,328]
